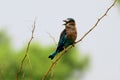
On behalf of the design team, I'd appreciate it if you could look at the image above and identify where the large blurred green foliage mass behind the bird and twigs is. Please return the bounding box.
[0,31,90,80]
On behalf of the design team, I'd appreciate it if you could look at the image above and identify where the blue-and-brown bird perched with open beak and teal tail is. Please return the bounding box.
[48,18,77,60]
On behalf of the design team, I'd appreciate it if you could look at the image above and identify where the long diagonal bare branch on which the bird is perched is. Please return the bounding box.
[42,0,117,80]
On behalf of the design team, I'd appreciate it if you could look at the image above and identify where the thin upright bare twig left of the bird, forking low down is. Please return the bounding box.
[16,19,36,80]
